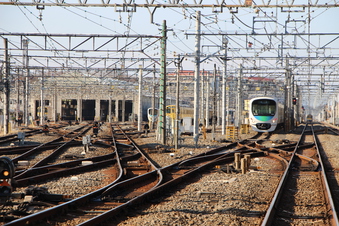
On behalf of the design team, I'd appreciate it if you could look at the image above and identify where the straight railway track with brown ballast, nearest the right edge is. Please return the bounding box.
[262,124,338,225]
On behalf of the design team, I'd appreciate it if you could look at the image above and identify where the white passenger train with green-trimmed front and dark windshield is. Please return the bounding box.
[249,97,284,132]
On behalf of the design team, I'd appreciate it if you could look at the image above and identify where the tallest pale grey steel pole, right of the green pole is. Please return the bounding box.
[193,11,201,141]
